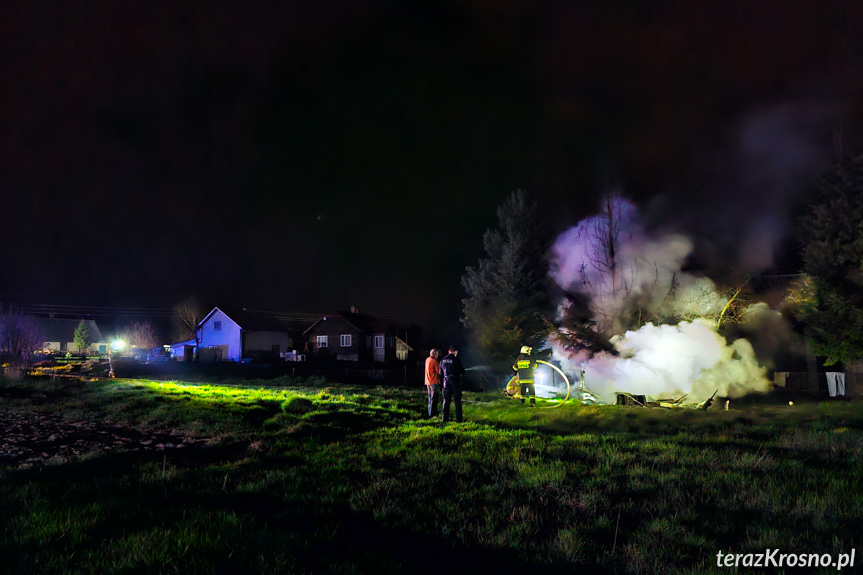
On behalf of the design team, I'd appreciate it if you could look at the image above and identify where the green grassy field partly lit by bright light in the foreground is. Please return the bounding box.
[0,379,863,574]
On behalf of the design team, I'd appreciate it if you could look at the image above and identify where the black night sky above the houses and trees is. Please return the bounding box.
[0,0,863,340]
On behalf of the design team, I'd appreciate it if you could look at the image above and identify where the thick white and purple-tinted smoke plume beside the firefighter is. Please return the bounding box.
[550,198,780,401]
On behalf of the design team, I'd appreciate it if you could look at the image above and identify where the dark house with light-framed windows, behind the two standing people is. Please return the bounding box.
[303,308,398,363]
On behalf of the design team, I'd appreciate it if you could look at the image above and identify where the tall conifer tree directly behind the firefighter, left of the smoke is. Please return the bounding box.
[461,190,551,366]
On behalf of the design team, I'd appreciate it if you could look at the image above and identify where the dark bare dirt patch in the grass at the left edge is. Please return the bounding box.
[0,410,207,469]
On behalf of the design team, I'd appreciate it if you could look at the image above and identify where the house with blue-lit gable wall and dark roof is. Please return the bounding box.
[196,307,293,362]
